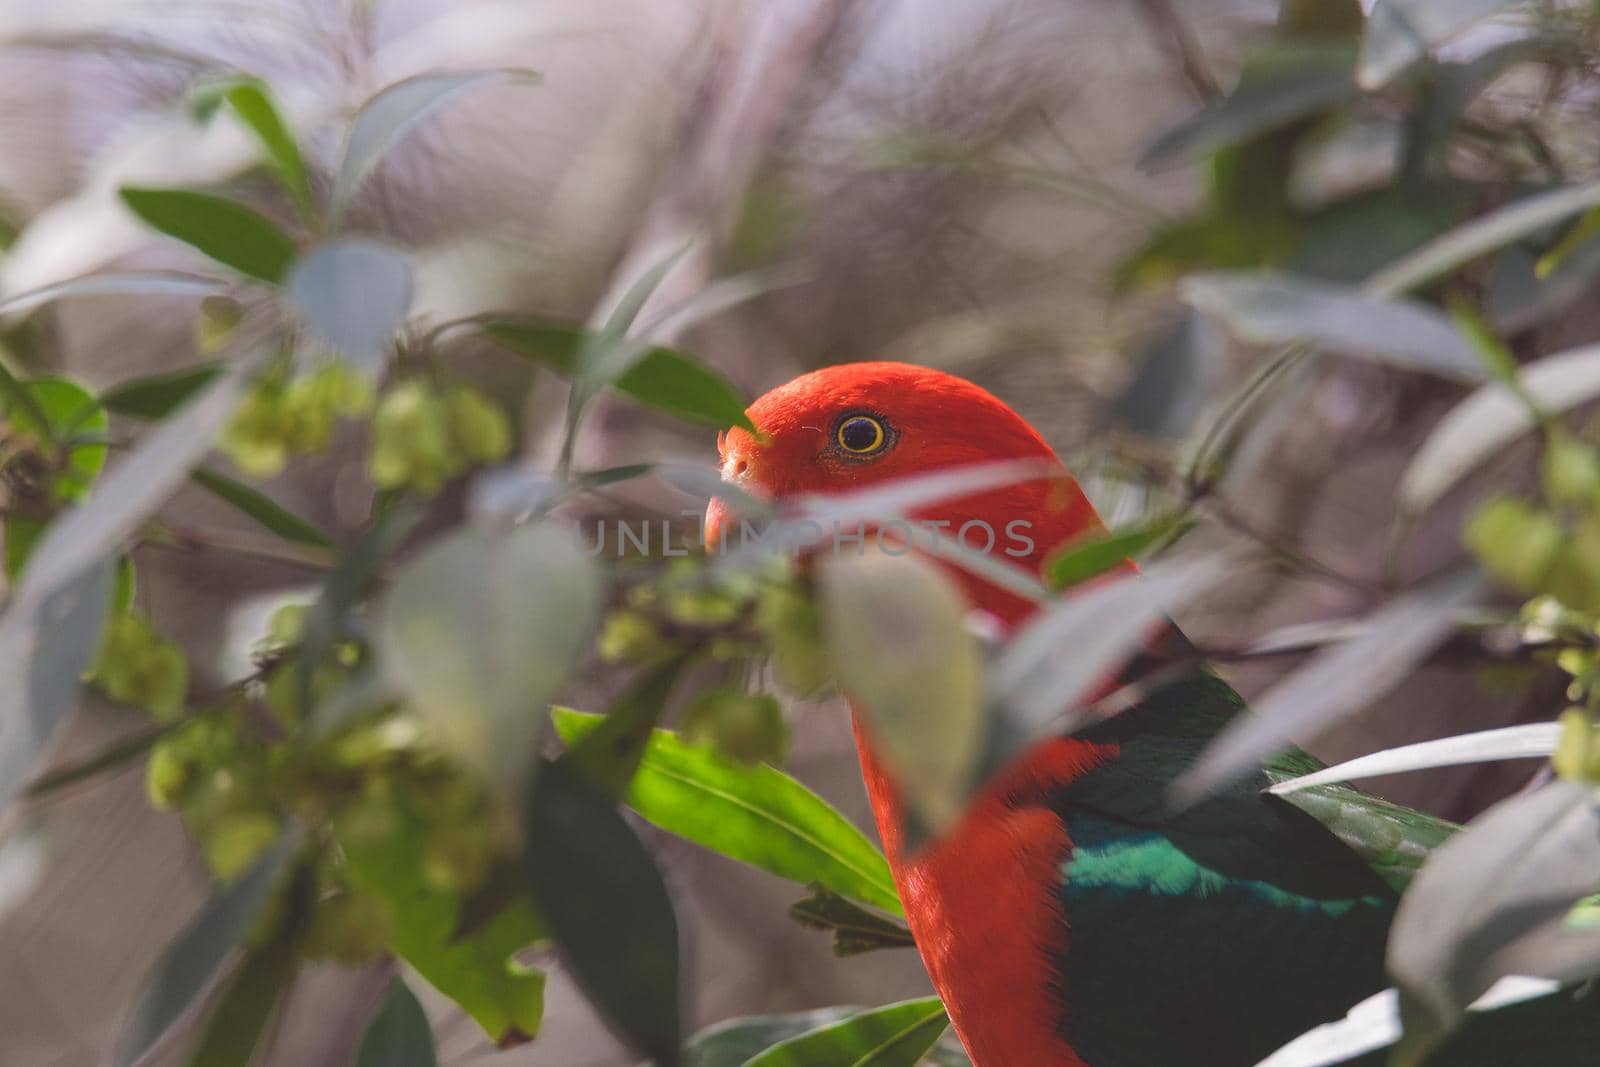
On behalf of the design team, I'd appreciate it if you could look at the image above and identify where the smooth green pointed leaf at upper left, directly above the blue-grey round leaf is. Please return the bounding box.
[120,187,296,285]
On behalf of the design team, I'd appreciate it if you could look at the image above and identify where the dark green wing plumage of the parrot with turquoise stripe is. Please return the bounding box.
[1051,670,1600,1067]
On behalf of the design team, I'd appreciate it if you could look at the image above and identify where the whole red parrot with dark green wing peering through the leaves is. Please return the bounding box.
[706,362,1600,1067]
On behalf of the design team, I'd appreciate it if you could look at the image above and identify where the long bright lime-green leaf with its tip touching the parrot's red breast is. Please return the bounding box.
[554,707,904,915]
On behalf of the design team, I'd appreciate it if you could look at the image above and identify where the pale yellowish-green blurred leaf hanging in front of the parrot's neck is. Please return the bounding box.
[819,547,984,832]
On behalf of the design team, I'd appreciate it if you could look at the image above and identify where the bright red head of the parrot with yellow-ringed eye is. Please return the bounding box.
[706,362,1104,624]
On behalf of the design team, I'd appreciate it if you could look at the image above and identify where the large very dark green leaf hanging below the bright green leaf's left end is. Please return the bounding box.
[523,761,682,1067]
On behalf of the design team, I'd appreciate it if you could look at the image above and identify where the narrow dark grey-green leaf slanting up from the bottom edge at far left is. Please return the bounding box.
[110,837,299,1067]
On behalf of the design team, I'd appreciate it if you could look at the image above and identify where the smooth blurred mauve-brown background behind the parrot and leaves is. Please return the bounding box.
[0,0,1574,1067]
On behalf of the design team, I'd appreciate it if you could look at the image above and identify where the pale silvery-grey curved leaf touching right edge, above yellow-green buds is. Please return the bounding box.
[1397,346,1600,515]
